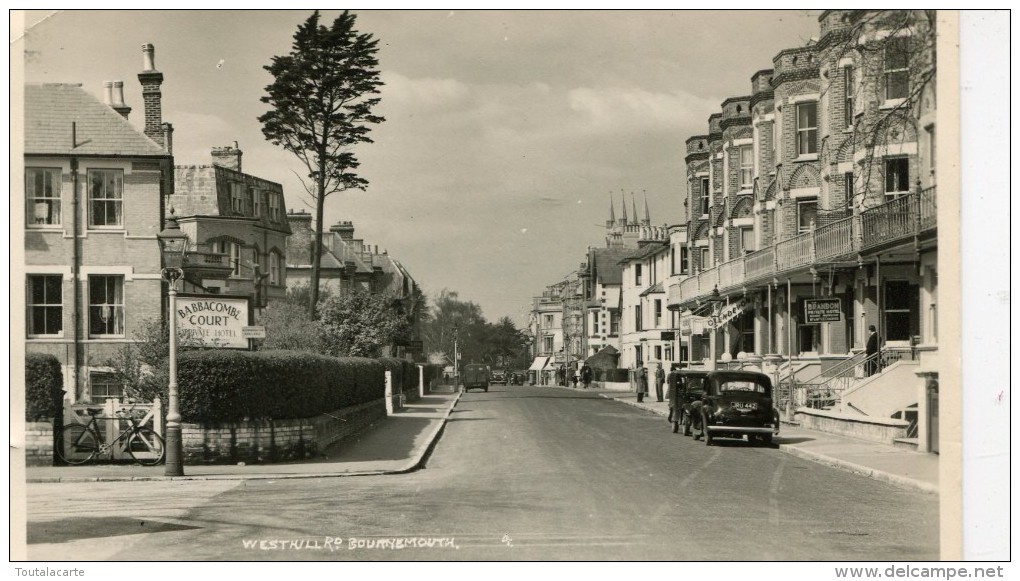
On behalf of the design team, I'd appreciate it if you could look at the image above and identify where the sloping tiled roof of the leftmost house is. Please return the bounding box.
[24,84,170,157]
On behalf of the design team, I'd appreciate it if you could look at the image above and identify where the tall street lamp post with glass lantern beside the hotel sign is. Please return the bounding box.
[156,209,188,476]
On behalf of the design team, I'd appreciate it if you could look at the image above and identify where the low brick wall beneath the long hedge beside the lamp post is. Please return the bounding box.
[182,399,386,464]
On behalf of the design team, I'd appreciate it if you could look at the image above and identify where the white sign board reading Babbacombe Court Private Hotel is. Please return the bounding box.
[177,297,248,349]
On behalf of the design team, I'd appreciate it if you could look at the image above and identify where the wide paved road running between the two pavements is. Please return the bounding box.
[29,386,938,561]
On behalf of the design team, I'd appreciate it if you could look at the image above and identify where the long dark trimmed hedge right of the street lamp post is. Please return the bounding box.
[177,350,383,423]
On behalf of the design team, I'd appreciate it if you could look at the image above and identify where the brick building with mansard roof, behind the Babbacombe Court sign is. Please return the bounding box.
[169,142,291,309]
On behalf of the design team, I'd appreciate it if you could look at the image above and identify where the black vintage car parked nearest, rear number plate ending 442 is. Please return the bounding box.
[684,371,779,445]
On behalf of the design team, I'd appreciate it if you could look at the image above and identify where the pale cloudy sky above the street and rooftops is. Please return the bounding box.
[15,10,818,325]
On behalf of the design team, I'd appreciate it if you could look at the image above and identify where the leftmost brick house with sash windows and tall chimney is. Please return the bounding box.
[24,45,173,402]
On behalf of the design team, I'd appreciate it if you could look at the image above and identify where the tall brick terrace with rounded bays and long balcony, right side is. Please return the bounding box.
[667,10,938,450]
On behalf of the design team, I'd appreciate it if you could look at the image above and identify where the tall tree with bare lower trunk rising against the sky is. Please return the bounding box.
[259,10,385,318]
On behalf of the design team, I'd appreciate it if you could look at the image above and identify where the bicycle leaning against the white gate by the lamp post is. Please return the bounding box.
[57,399,166,466]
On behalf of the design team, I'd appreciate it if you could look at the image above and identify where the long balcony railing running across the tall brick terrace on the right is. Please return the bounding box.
[667,186,937,306]
